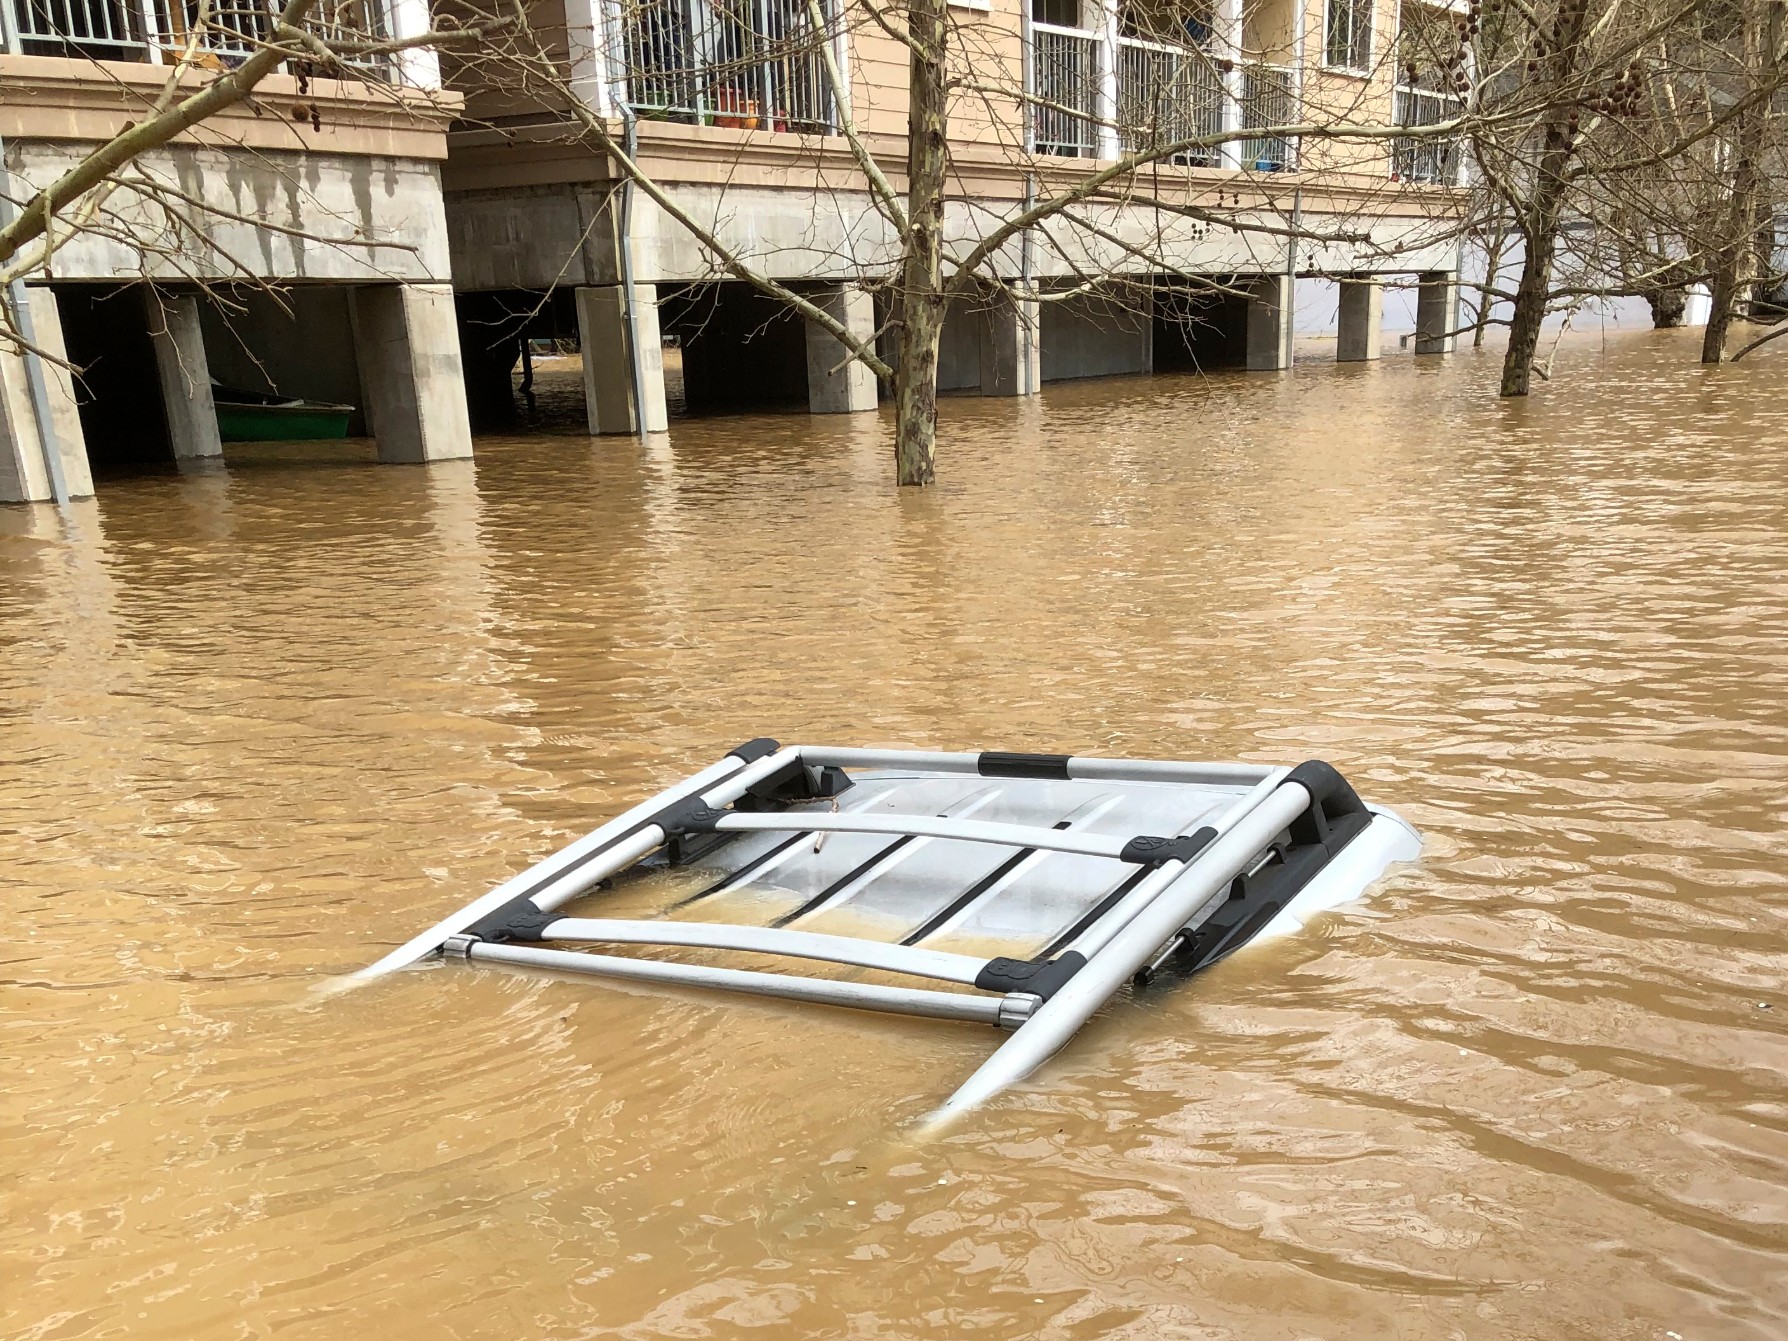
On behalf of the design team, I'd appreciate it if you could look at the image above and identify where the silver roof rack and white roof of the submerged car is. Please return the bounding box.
[354,740,1421,1116]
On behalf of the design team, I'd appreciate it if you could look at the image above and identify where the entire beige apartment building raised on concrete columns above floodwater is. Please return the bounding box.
[0,0,1459,499]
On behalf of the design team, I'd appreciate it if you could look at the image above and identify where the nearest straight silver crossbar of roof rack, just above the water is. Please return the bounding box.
[451,937,1033,1026]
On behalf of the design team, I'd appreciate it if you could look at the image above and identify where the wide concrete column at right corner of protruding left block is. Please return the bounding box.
[350,284,472,463]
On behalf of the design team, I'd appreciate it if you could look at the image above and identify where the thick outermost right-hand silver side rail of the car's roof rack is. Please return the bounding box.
[932,783,1311,1123]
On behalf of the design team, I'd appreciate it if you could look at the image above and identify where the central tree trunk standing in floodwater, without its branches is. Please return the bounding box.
[894,0,949,485]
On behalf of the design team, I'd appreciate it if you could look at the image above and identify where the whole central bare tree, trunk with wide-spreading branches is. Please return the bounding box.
[443,0,1463,485]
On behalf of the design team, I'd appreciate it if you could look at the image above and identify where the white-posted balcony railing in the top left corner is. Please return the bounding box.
[0,0,392,79]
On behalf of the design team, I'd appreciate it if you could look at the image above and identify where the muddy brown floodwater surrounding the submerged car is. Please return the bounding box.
[0,333,1788,1341]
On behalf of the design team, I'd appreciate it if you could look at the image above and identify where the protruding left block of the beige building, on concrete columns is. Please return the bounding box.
[0,0,472,501]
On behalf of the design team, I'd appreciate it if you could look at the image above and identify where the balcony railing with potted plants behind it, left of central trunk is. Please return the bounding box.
[622,0,833,134]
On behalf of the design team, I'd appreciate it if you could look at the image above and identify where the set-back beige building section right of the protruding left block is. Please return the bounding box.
[443,0,1459,433]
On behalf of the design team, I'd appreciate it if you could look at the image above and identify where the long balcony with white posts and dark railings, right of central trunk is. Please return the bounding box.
[1030,21,1298,172]
